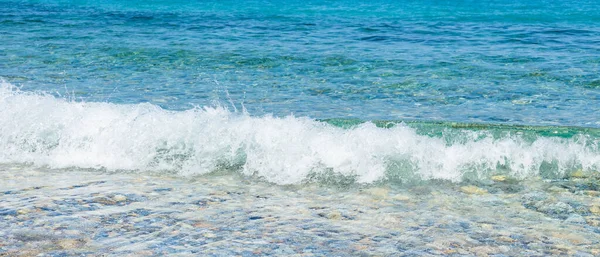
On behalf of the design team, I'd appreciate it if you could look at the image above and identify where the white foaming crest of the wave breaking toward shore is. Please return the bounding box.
[0,82,600,184]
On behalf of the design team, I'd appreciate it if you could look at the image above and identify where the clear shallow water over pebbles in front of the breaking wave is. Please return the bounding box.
[0,165,600,256]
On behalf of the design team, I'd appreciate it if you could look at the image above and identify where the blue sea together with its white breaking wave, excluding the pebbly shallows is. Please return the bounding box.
[0,0,600,184]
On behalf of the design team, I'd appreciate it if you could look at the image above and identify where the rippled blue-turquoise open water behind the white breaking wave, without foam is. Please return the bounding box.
[0,0,600,124]
